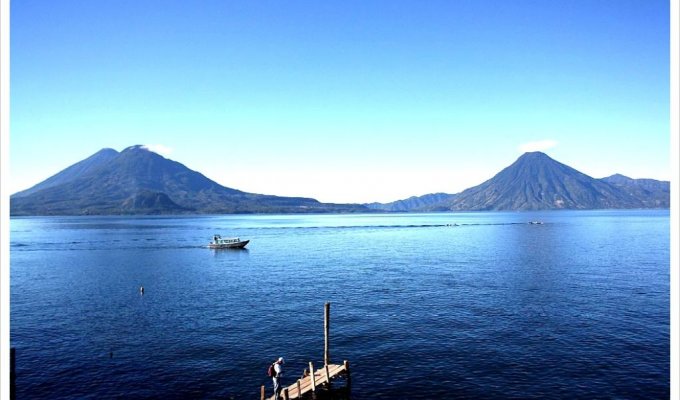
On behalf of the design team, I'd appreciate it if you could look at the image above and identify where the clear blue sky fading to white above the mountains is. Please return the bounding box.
[10,0,671,202]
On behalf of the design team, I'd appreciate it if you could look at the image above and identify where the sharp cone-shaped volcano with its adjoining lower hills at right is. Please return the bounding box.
[374,152,670,212]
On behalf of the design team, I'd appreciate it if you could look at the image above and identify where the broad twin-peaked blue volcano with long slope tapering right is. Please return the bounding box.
[10,146,368,215]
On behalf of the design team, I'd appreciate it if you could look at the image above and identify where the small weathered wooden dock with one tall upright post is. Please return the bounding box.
[260,303,351,400]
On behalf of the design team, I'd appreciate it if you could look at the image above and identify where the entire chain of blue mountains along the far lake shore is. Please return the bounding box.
[10,145,670,216]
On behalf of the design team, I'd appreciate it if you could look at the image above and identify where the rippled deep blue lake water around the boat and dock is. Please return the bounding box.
[10,211,670,399]
